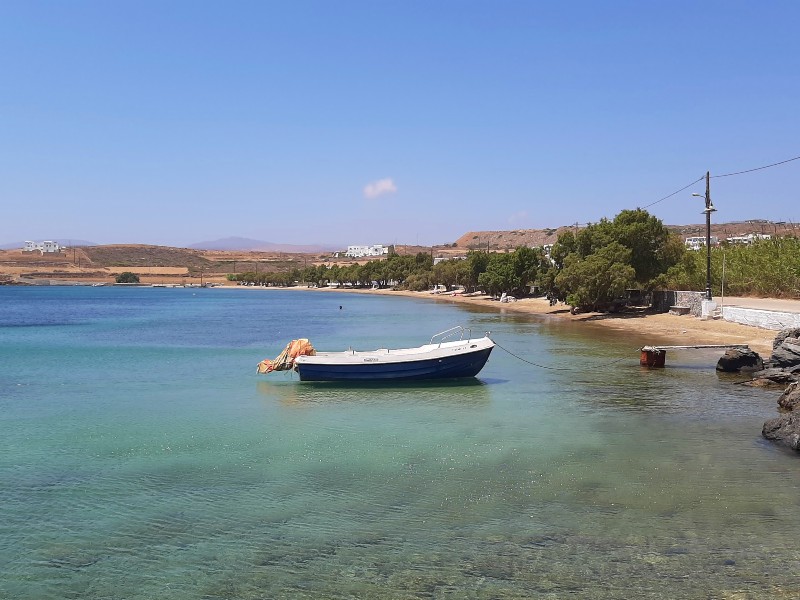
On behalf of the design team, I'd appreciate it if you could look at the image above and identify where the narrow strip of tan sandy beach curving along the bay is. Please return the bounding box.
[312,288,777,360]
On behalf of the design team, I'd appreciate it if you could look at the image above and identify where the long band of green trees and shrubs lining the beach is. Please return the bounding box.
[228,209,800,310]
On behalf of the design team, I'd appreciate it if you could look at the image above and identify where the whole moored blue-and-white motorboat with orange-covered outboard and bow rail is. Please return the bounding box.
[258,325,495,381]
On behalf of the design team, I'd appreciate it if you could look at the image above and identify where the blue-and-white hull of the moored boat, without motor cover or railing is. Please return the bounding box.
[294,338,494,381]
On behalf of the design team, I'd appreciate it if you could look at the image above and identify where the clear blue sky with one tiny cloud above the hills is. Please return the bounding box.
[0,0,800,246]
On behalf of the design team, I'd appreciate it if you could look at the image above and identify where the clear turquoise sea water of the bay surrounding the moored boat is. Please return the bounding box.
[0,286,800,600]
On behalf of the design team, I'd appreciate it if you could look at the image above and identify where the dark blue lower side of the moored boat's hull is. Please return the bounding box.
[296,348,492,381]
